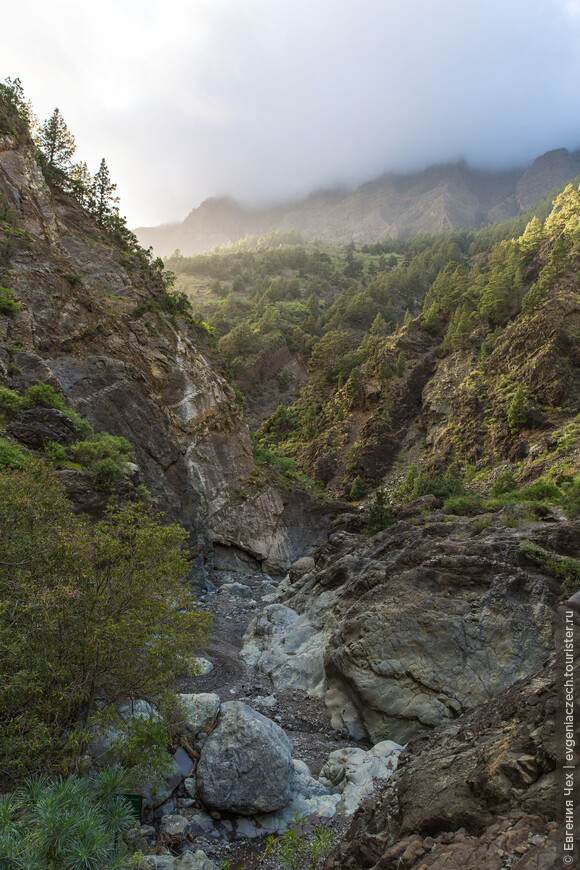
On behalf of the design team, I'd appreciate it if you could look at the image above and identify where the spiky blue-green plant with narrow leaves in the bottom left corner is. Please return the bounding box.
[0,768,135,870]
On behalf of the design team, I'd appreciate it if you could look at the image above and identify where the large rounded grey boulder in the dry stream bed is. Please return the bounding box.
[197,701,294,816]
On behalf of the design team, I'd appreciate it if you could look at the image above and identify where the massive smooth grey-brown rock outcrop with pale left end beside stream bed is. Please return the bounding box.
[242,512,580,743]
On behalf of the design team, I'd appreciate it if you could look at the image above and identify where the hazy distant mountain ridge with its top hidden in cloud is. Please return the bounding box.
[135,148,580,256]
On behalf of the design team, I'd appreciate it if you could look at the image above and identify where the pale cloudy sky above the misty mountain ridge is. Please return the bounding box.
[0,0,580,227]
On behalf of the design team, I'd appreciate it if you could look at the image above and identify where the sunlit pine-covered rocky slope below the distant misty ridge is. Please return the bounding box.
[167,185,580,511]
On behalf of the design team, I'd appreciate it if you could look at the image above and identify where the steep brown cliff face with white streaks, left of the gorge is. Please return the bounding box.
[0,136,325,567]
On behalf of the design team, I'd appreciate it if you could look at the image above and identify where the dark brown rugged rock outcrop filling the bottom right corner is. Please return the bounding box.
[325,665,563,870]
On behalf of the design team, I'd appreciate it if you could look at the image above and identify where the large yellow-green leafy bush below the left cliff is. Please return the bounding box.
[0,466,209,779]
